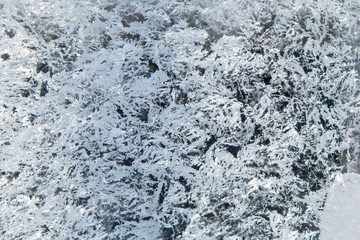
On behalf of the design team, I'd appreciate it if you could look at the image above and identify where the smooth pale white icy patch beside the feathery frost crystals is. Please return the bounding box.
[320,173,360,240]
